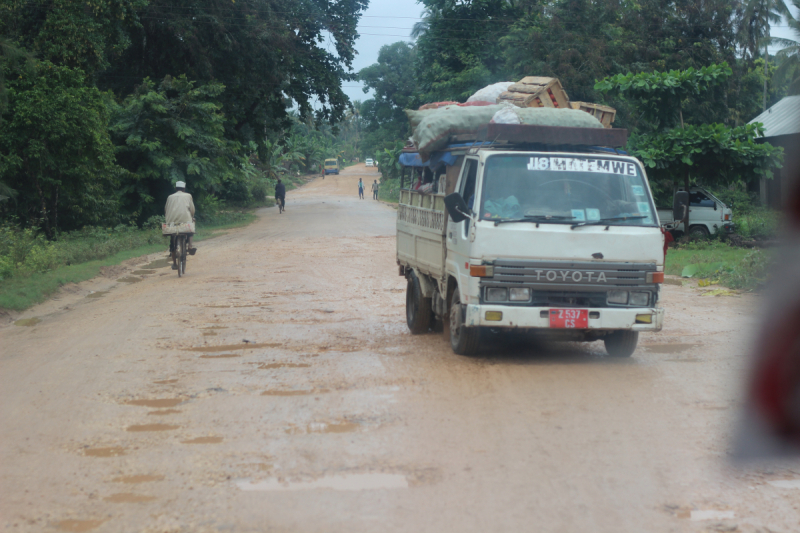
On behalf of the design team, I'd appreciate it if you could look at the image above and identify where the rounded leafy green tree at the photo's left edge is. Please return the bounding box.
[0,61,119,234]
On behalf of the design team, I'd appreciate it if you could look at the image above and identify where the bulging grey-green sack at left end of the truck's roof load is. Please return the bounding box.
[416,105,504,157]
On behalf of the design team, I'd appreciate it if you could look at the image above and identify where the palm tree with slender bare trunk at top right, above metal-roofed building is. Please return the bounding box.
[738,0,792,110]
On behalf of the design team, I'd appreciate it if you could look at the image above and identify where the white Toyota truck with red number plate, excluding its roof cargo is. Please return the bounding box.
[397,124,668,357]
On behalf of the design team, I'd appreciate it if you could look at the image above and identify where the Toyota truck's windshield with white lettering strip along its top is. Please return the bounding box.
[479,154,656,226]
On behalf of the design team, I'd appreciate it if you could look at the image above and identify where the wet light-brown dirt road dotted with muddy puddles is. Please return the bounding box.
[0,166,800,533]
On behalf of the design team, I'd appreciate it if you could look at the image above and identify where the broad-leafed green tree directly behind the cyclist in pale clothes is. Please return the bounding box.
[110,76,255,222]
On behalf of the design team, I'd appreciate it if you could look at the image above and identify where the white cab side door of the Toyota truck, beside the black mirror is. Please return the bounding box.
[447,158,478,303]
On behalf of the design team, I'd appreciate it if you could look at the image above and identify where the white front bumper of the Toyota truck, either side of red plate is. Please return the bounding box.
[464,305,664,331]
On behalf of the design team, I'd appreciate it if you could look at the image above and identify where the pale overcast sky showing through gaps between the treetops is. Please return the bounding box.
[318,0,800,108]
